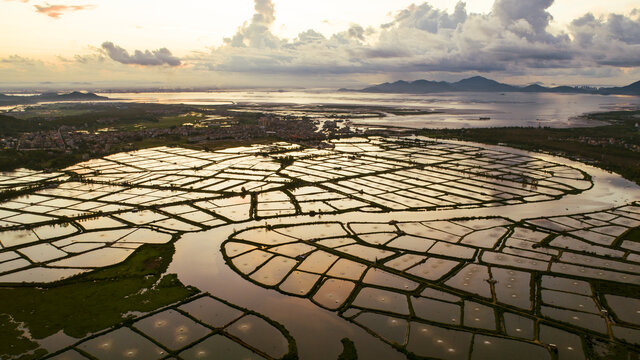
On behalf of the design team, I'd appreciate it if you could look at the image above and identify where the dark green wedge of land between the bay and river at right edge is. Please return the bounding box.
[421,111,640,184]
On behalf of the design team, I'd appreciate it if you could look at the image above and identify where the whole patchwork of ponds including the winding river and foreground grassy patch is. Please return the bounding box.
[0,137,640,359]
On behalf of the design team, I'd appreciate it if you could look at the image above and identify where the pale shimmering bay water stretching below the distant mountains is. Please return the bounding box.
[101,91,640,128]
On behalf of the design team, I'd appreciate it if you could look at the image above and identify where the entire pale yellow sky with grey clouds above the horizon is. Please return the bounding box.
[0,0,640,89]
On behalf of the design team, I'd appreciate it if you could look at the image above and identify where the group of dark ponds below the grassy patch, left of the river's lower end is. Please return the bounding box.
[53,296,296,359]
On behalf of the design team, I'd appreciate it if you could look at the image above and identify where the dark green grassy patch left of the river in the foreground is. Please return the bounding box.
[0,244,199,358]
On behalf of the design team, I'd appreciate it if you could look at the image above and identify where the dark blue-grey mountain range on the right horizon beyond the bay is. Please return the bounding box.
[339,76,640,95]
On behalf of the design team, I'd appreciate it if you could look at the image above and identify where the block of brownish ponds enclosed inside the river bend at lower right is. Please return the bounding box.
[222,205,640,359]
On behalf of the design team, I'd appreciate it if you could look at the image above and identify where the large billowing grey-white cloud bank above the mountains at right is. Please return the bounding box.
[185,0,640,76]
